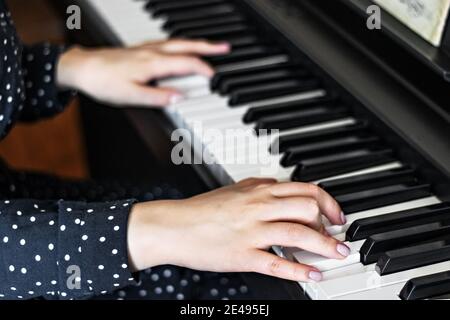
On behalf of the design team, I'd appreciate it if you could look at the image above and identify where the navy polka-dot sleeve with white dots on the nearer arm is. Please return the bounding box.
[0,200,135,299]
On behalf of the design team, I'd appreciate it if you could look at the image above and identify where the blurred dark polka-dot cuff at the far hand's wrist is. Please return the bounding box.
[20,43,74,121]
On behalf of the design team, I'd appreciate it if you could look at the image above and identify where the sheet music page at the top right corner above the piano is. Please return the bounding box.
[373,0,450,47]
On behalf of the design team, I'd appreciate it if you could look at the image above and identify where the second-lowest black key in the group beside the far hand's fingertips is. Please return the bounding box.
[218,68,309,95]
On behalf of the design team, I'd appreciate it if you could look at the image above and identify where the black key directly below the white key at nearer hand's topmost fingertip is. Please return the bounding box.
[346,203,450,241]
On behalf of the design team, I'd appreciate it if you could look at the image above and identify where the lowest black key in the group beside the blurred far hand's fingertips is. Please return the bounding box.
[229,79,320,106]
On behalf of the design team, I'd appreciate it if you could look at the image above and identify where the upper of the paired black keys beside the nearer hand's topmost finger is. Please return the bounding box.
[319,168,417,196]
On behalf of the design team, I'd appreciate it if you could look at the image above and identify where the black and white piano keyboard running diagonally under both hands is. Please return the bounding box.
[82,0,450,300]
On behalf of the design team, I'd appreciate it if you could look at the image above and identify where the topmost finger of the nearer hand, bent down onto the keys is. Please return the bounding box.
[270,182,347,225]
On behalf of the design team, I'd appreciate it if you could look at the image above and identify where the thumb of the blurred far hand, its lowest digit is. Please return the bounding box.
[127,85,183,107]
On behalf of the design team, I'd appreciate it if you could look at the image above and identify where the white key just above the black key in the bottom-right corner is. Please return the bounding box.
[314,261,450,299]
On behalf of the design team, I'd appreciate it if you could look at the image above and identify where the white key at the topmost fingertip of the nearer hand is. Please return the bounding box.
[324,196,441,236]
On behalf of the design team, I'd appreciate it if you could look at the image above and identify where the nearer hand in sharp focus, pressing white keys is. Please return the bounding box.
[128,179,350,282]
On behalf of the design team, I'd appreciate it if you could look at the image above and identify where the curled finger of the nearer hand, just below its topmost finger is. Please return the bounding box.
[262,197,324,232]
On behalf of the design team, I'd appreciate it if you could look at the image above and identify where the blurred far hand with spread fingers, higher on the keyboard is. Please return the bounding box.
[57,40,230,107]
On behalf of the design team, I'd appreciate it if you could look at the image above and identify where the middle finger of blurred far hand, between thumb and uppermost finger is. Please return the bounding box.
[151,55,214,78]
